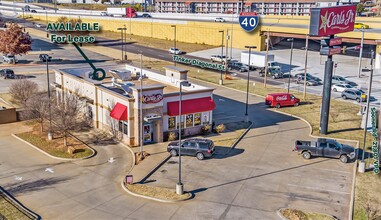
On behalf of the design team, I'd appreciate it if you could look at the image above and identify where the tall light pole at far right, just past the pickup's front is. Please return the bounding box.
[358,50,374,173]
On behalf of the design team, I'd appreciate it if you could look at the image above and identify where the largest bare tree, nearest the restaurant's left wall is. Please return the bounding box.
[52,92,84,146]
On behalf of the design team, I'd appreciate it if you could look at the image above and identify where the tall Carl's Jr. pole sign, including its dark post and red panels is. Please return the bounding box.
[309,5,356,134]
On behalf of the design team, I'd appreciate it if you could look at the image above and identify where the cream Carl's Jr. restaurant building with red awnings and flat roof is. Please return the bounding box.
[55,65,216,146]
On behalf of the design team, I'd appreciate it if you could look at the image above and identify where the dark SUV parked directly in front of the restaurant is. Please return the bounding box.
[167,138,214,160]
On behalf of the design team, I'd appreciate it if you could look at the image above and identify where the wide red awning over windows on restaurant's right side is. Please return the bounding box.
[167,97,216,116]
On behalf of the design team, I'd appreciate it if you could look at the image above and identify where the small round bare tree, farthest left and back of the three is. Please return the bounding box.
[9,79,38,107]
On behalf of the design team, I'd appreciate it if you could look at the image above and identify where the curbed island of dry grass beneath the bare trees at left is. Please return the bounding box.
[16,126,93,159]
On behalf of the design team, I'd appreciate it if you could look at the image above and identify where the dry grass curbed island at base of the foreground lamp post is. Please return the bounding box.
[126,184,188,200]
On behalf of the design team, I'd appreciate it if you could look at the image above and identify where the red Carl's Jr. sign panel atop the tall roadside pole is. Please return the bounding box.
[310,5,356,37]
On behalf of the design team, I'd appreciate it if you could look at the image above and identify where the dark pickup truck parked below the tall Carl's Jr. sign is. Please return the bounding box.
[292,138,356,163]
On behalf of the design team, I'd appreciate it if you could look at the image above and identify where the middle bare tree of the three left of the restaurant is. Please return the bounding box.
[23,92,49,132]
